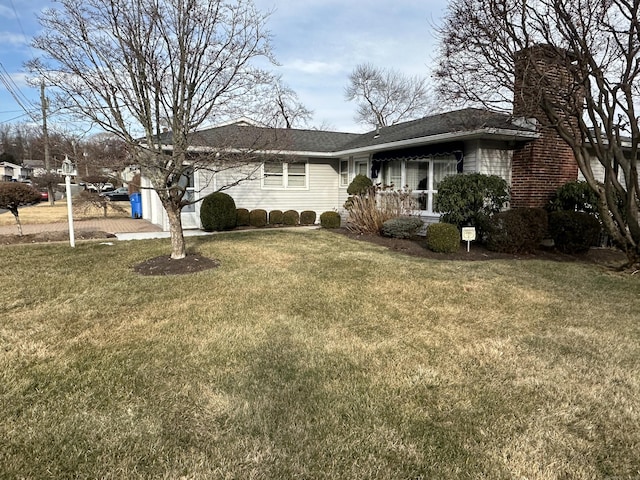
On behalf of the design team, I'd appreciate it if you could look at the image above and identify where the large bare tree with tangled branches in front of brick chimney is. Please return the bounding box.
[437,0,640,266]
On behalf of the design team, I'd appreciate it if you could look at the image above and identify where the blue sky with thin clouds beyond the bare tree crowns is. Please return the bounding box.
[0,0,447,132]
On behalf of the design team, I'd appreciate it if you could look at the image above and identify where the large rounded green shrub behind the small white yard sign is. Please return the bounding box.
[435,173,509,238]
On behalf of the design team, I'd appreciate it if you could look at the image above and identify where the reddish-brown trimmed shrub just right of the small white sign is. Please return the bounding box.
[487,208,547,253]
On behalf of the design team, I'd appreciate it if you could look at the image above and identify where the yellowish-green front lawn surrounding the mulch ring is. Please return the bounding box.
[0,229,640,480]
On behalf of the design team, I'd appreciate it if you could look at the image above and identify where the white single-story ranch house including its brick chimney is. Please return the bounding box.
[142,45,636,230]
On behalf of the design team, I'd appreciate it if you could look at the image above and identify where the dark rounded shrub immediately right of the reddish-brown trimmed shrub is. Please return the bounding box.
[549,210,601,254]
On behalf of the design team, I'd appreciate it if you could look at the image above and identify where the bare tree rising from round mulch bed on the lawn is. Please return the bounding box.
[30,0,271,259]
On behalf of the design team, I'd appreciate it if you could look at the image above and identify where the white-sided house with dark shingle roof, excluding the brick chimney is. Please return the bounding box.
[142,108,552,230]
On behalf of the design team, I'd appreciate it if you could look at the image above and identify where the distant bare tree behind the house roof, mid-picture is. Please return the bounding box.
[345,64,432,128]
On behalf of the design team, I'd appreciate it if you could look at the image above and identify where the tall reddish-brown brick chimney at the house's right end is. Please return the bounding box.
[511,45,581,208]
